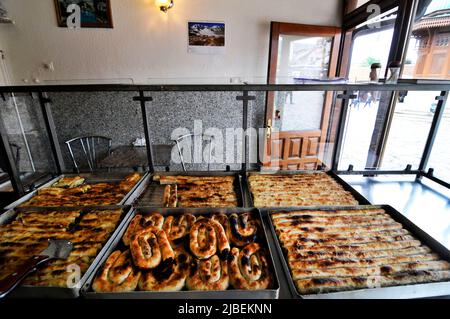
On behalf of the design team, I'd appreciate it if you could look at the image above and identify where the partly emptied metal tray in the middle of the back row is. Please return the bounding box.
[125,171,247,208]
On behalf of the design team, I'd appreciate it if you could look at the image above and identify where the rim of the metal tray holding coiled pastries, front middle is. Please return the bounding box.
[81,207,280,299]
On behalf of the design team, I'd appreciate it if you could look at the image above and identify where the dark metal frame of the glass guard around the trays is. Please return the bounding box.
[0,80,450,200]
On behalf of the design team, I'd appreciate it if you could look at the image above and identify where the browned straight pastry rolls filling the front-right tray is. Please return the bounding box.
[271,209,450,295]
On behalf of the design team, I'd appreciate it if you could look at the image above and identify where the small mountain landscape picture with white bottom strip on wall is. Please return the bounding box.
[188,22,225,54]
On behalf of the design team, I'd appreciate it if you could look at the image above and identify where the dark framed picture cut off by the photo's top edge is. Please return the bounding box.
[55,0,113,28]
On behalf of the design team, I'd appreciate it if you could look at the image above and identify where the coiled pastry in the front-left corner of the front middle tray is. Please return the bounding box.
[92,250,141,292]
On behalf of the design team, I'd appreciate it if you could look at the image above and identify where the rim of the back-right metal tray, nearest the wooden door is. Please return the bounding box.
[242,170,371,208]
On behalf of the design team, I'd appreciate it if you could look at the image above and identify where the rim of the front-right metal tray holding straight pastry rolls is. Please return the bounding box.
[260,205,450,299]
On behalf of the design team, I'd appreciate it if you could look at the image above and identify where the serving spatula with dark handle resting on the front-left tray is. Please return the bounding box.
[0,239,73,299]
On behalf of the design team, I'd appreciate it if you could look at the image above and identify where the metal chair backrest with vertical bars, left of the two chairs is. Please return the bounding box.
[65,136,112,173]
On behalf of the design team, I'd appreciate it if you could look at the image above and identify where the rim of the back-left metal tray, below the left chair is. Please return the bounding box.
[4,172,148,210]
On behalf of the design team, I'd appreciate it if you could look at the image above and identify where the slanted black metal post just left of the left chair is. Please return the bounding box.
[38,92,65,174]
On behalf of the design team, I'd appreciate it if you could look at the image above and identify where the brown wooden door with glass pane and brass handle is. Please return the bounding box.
[263,22,341,170]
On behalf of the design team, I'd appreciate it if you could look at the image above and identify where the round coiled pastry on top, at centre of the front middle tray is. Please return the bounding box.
[189,218,230,259]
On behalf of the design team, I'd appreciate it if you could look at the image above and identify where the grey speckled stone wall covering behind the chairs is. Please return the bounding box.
[48,92,265,170]
